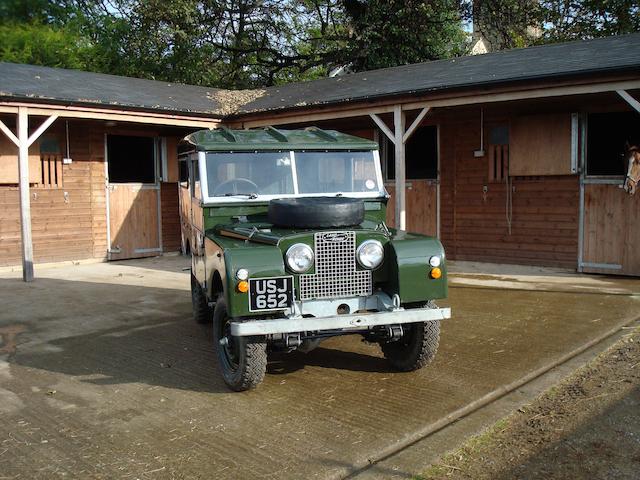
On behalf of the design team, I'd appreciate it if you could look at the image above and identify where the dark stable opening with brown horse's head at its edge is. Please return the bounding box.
[587,112,640,176]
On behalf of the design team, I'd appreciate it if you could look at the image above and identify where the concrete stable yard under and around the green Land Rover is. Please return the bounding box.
[0,257,640,479]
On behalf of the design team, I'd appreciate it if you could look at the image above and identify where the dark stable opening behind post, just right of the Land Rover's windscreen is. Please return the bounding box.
[378,125,438,180]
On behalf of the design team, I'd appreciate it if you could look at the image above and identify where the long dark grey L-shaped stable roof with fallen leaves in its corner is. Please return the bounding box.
[0,33,640,118]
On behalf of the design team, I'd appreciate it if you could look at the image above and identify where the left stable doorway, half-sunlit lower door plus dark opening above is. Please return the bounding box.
[107,135,162,260]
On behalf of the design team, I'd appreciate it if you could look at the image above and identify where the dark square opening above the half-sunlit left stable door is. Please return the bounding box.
[107,135,156,183]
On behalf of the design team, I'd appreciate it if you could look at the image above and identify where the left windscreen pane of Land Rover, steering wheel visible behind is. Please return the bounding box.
[207,152,294,197]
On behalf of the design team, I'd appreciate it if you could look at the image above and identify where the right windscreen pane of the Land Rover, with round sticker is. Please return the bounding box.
[295,151,380,193]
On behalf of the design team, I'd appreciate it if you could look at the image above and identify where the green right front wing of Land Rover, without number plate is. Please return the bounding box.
[387,232,447,303]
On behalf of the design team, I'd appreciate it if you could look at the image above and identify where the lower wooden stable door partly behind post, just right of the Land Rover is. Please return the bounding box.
[385,180,438,237]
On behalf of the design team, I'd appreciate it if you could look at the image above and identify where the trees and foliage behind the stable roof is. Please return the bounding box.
[0,0,640,88]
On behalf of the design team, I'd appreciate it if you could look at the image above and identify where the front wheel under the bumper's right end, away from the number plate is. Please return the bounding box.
[380,308,440,372]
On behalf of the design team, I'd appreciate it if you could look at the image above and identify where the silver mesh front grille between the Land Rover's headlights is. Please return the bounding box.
[300,232,372,300]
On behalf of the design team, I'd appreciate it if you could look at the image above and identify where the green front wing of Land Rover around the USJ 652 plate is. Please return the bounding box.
[223,245,289,317]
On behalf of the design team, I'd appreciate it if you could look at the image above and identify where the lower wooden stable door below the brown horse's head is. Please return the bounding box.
[582,180,640,276]
